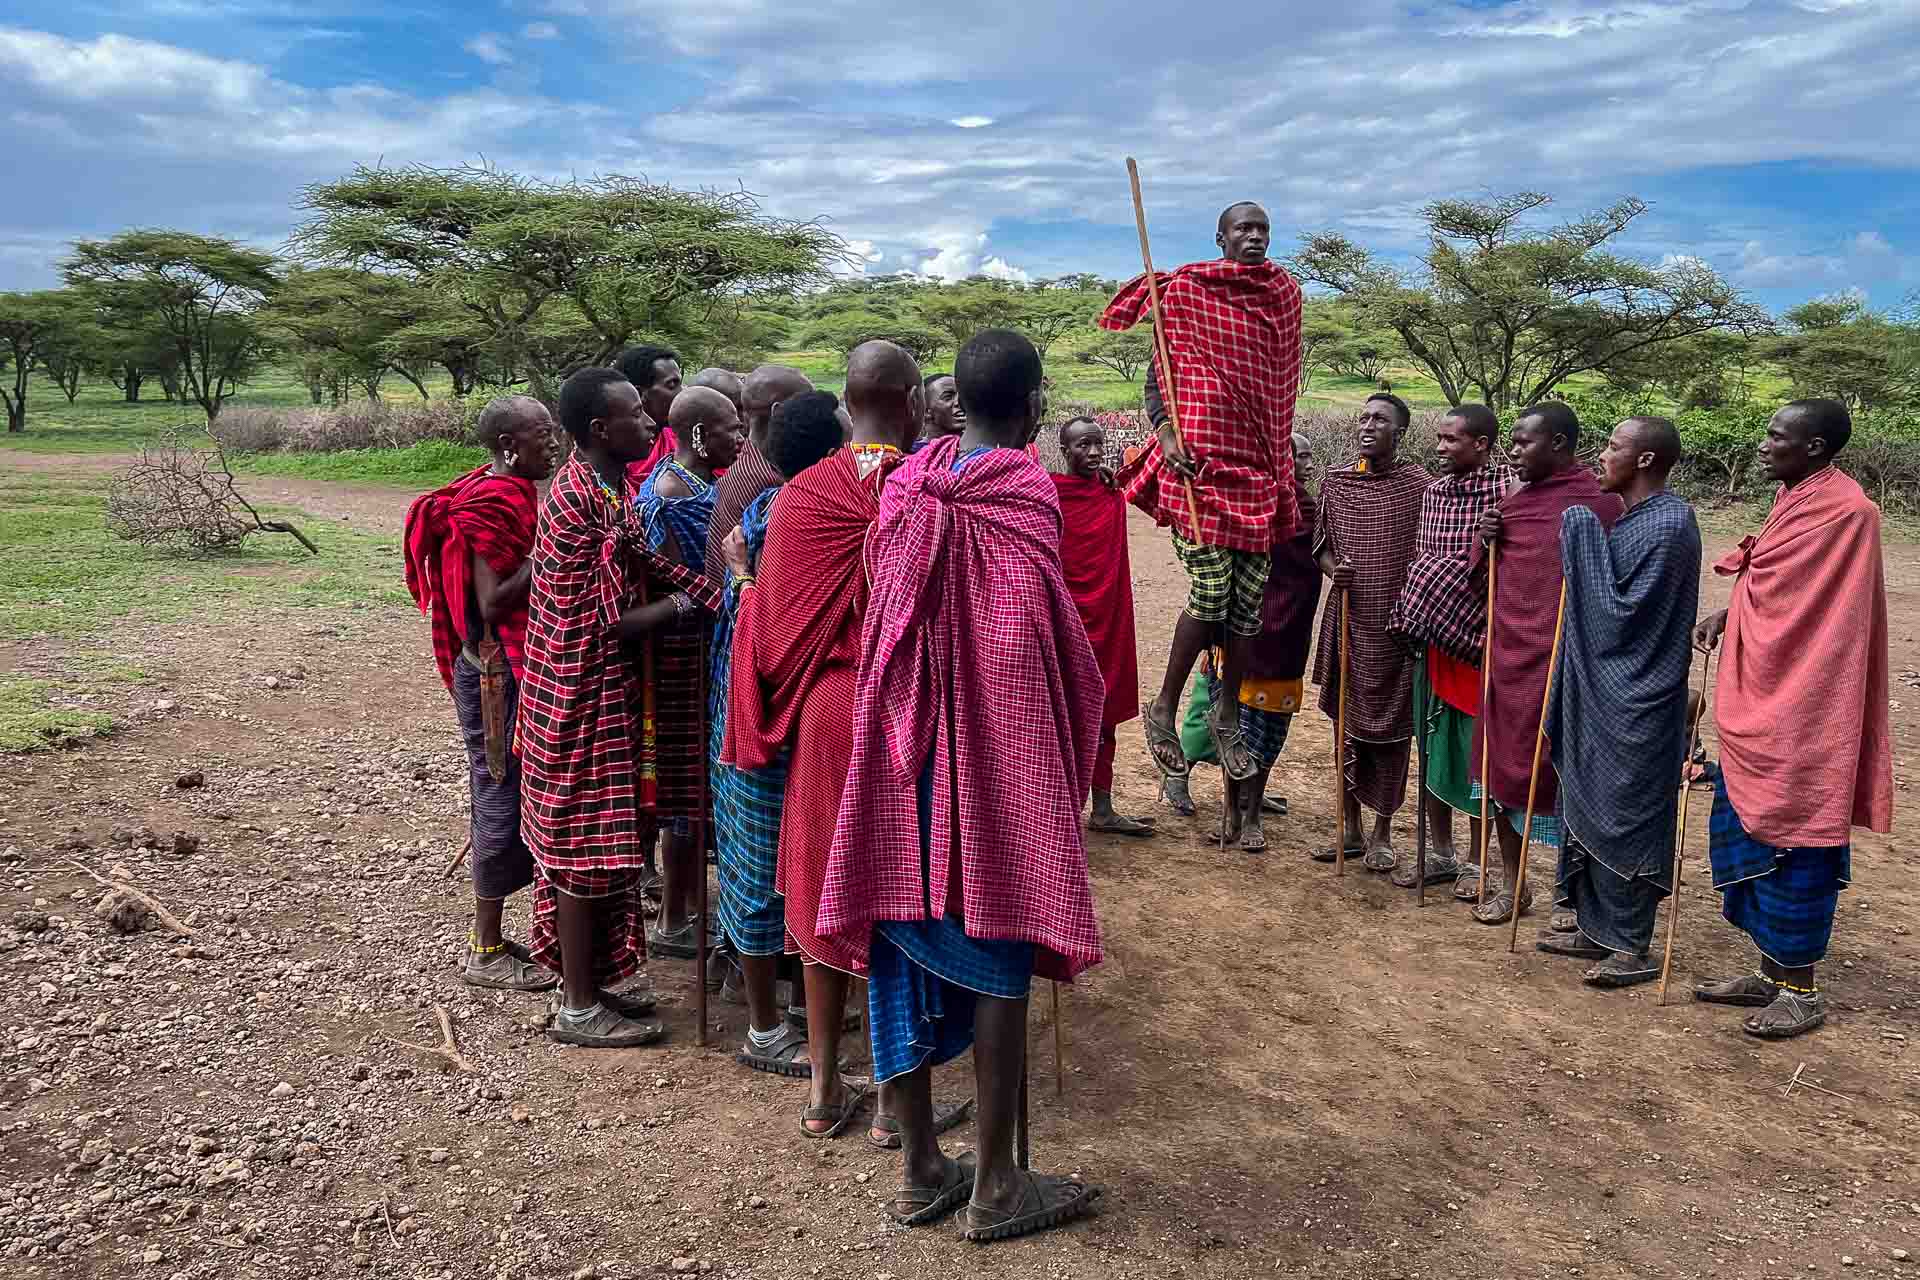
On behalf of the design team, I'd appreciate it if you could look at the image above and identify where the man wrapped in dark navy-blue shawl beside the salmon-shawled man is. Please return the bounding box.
[1536,418,1699,986]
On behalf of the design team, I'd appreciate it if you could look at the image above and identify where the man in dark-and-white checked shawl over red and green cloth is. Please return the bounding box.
[1386,405,1519,902]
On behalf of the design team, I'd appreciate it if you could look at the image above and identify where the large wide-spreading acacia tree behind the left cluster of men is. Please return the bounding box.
[292,165,849,393]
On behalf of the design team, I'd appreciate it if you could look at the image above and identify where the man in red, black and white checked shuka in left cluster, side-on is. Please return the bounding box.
[520,368,718,1048]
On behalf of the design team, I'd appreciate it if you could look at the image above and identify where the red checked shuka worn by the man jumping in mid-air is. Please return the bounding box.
[1100,259,1300,553]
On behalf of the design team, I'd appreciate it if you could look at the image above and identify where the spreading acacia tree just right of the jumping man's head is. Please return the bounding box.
[1288,192,1766,409]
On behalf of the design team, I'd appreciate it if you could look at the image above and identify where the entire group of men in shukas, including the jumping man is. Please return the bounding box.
[407,195,1891,1240]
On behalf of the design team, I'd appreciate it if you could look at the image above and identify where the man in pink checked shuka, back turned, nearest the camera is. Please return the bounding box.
[818,330,1106,1242]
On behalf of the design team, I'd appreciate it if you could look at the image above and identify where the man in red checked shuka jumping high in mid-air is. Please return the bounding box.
[1100,201,1300,781]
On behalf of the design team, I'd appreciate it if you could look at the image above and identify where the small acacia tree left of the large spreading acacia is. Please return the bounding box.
[61,230,280,422]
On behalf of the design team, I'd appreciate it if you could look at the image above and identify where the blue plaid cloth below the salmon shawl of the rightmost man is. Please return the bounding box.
[1707,770,1853,969]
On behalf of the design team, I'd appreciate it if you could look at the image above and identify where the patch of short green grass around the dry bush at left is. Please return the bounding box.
[0,472,407,644]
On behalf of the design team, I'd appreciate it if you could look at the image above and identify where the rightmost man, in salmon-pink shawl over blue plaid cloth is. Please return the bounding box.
[1693,399,1893,1040]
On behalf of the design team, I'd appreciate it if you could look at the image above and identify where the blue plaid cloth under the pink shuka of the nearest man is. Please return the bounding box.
[866,758,1033,1082]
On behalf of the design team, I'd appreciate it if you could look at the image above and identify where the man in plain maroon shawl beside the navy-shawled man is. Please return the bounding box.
[1473,401,1620,925]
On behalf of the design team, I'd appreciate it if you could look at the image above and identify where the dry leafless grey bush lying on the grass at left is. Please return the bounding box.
[108,428,319,555]
